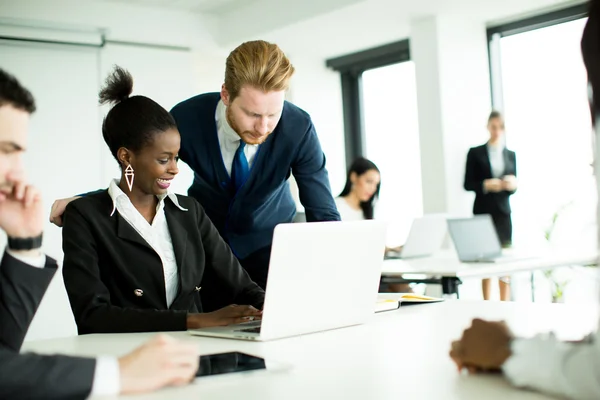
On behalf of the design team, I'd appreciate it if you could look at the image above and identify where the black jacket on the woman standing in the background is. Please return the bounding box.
[465,144,517,215]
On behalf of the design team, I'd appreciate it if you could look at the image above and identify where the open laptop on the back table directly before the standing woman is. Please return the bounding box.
[448,214,532,263]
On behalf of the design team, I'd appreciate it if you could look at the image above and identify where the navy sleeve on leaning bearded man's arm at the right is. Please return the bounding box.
[292,122,340,222]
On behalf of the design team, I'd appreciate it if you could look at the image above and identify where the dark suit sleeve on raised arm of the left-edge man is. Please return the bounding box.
[0,253,57,351]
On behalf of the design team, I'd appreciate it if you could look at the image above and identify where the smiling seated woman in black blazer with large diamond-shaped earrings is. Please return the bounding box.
[63,67,264,334]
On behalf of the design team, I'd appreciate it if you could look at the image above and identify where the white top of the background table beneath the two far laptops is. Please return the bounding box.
[381,250,598,278]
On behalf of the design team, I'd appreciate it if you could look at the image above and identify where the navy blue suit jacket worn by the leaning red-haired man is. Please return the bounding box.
[171,93,340,259]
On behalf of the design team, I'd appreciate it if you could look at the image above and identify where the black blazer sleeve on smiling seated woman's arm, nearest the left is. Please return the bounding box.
[63,202,187,334]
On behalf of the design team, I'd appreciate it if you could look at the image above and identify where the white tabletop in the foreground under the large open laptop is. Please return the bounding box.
[24,301,598,400]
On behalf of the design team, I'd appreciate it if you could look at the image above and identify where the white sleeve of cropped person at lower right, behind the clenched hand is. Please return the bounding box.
[502,333,600,399]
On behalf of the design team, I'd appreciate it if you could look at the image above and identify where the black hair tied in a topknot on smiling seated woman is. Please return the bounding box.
[99,66,177,164]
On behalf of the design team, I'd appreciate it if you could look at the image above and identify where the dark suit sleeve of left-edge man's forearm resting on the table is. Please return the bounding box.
[0,346,96,400]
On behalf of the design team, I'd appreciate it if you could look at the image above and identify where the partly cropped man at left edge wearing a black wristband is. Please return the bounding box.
[0,70,198,399]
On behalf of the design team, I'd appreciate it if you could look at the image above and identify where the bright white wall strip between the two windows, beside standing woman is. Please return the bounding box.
[438,15,491,215]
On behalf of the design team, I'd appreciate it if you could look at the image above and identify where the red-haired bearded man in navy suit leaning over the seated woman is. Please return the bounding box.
[50,40,340,296]
